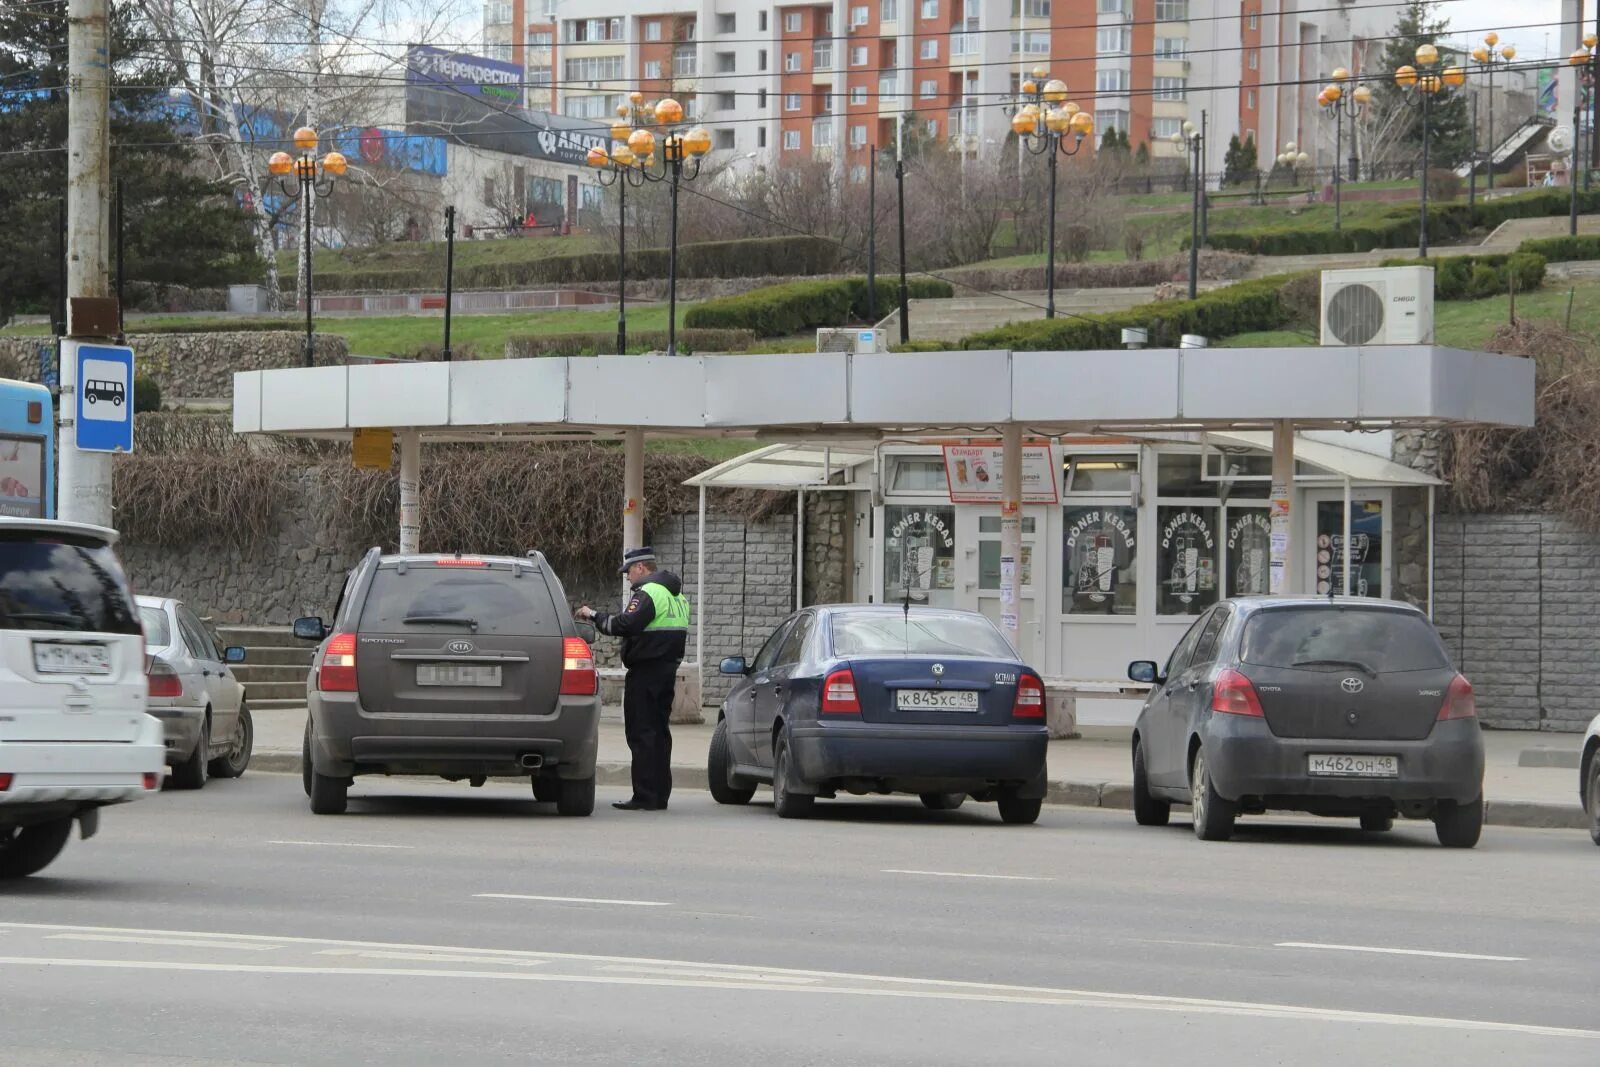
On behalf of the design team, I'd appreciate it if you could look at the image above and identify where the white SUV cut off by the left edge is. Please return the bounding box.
[0,518,166,880]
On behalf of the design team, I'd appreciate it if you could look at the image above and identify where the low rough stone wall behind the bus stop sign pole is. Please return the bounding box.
[0,330,350,403]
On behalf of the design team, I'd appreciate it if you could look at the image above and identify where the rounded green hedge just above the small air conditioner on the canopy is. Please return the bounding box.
[683,278,955,338]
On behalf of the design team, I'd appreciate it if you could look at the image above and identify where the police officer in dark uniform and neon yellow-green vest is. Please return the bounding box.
[578,547,690,811]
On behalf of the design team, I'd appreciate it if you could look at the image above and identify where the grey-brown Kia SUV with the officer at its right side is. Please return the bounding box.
[294,549,600,816]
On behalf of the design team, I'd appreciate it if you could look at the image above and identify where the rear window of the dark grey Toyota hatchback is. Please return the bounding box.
[1240,606,1450,672]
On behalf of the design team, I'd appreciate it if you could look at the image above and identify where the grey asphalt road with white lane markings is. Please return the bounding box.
[0,773,1600,1067]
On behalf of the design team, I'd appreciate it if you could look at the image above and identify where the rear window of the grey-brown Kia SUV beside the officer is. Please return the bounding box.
[360,563,562,637]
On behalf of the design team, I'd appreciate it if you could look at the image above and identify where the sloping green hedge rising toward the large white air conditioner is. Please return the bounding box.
[960,274,1301,352]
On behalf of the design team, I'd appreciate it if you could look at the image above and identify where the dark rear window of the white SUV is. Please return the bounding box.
[0,531,141,633]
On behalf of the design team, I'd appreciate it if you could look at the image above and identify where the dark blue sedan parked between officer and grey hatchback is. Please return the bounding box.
[707,605,1050,822]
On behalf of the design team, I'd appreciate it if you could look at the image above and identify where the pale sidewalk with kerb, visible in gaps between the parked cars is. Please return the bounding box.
[251,709,1587,829]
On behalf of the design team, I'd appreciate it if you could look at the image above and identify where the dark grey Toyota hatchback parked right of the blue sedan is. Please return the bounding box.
[1128,597,1483,848]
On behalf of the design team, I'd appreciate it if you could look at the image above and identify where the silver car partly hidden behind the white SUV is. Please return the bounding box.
[138,597,254,789]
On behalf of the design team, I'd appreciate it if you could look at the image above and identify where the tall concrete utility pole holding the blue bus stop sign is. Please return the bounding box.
[58,0,116,526]
